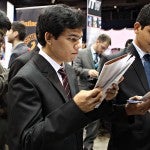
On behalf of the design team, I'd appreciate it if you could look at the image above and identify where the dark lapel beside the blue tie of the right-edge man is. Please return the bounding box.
[126,44,150,92]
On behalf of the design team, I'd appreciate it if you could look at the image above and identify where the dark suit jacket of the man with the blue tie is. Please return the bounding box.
[99,44,150,150]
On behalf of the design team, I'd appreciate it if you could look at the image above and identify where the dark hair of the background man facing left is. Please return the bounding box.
[11,21,26,41]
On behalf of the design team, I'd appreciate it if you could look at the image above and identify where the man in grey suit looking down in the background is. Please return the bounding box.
[73,34,111,150]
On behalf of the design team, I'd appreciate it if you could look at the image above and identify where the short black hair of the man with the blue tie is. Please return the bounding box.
[136,4,150,28]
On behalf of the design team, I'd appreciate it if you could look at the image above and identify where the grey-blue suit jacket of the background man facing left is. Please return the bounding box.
[8,43,30,68]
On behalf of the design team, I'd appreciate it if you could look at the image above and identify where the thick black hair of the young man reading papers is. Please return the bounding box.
[36,4,86,46]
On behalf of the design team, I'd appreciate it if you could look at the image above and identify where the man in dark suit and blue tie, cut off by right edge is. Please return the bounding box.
[99,4,150,150]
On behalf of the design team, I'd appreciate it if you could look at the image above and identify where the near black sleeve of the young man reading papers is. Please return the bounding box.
[8,75,91,150]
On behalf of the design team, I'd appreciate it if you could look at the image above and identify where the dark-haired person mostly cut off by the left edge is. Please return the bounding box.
[0,10,11,150]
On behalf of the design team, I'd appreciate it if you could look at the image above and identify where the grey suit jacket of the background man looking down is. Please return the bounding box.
[73,48,100,90]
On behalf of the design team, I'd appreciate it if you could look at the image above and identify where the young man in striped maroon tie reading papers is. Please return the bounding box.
[8,5,118,150]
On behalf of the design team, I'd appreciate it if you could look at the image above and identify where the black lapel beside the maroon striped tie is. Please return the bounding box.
[32,54,70,101]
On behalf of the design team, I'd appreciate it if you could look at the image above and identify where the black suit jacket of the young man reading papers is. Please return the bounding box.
[8,54,112,150]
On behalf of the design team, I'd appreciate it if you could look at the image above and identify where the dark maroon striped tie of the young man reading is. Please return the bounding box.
[58,68,72,99]
